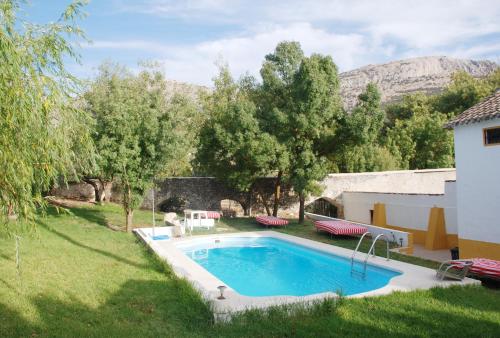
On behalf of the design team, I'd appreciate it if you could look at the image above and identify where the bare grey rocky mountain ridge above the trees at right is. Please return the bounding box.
[340,56,498,110]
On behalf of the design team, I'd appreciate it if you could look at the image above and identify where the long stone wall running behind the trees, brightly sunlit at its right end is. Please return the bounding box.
[51,169,456,217]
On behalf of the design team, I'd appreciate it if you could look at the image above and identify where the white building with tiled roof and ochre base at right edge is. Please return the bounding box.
[446,89,500,260]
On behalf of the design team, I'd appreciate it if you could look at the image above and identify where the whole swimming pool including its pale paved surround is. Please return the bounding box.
[134,229,481,320]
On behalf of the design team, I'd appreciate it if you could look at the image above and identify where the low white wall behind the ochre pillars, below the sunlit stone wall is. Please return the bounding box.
[342,181,458,234]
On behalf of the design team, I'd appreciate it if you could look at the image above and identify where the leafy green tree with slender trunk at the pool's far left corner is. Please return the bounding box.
[84,65,189,231]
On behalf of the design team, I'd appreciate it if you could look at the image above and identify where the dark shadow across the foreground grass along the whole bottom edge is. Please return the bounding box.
[0,278,499,337]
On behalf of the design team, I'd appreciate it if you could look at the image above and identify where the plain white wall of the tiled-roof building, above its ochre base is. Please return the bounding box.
[455,118,500,243]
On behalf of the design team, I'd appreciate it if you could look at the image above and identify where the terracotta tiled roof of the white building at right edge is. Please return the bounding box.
[444,88,500,128]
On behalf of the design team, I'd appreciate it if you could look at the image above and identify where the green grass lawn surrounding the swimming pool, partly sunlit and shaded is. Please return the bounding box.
[0,204,500,337]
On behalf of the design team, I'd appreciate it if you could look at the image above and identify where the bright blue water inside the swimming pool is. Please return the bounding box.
[178,237,401,297]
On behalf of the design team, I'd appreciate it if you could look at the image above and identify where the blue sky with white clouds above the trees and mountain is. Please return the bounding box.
[22,0,500,86]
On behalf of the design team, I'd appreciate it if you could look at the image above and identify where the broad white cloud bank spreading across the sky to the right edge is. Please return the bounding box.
[91,0,500,85]
